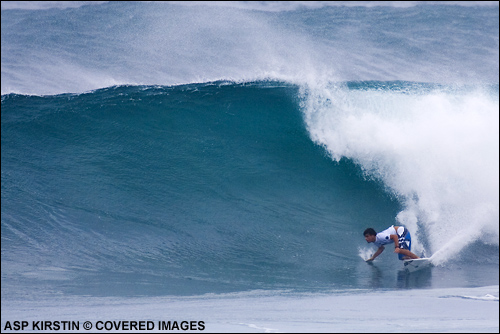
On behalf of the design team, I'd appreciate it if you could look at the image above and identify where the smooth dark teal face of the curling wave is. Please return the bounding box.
[2,83,399,296]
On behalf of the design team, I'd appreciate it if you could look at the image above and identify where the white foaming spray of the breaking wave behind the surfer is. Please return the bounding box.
[303,85,499,264]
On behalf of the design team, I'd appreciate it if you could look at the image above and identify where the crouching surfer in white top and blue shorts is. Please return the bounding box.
[363,225,419,262]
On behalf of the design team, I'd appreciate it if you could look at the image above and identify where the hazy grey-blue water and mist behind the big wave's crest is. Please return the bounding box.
[2,2,499,95]
